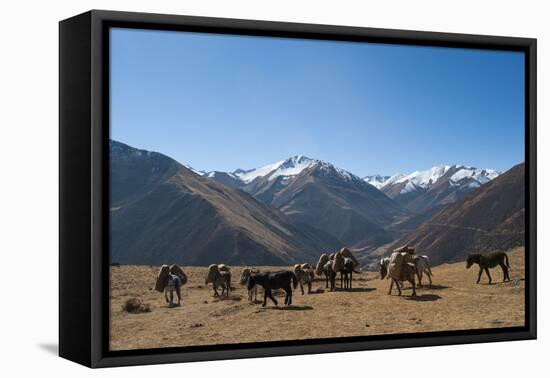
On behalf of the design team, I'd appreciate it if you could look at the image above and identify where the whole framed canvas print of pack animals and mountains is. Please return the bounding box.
[59,11,536,367]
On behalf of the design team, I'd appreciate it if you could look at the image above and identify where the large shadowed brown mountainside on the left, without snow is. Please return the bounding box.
[111,142,339,265]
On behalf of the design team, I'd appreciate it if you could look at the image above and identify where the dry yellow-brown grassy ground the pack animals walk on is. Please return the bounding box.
[110,248,525,350]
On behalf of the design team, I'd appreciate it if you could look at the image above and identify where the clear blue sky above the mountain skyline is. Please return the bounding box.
[111,29,524,176]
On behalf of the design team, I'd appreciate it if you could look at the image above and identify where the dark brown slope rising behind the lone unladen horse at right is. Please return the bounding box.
[393,164,525,264]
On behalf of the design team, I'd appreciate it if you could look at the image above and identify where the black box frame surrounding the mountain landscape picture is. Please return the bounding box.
[59,10,537,367]
